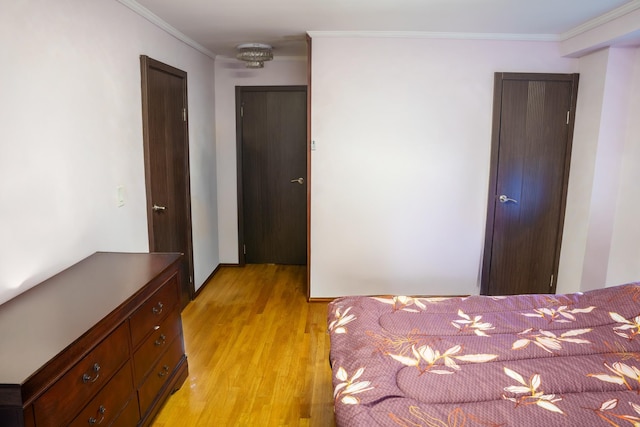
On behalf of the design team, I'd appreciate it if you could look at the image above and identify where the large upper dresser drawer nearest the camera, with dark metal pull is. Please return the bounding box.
[34,322,130,427]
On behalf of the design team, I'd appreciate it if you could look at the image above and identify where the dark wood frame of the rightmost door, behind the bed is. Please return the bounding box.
[480,72,579,295]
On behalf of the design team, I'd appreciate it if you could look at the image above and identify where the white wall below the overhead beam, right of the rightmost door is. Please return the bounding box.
[558,48,640,292]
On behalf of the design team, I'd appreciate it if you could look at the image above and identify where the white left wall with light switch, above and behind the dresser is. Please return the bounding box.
[0,0,219,308]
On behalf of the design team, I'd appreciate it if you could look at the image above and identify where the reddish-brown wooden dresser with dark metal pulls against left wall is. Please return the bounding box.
[0,252,188,427]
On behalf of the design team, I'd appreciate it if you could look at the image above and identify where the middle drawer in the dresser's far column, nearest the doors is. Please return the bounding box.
[133,305,182,384]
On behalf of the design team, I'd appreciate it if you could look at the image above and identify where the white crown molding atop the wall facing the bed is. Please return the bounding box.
[307,30,556,42]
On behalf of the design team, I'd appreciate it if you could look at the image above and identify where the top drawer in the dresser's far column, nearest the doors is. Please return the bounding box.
[131,275,178,348]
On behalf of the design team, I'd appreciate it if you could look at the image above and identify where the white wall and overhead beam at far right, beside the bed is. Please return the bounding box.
[557,10,640,293]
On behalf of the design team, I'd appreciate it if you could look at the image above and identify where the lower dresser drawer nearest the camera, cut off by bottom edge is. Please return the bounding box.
[69,363,133,427]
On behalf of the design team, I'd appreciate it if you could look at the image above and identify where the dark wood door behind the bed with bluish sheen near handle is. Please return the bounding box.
[482,73,578,295]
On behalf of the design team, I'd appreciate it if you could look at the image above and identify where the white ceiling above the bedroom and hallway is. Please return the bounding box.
[127,0,640,57]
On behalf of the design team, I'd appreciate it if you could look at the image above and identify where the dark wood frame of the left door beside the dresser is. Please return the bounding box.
[140,55,195,308]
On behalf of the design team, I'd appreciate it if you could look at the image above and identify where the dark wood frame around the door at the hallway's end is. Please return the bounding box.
[236,85,311,270]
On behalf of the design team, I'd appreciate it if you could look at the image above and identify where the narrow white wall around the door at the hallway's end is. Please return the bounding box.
[215,56,307,264]
